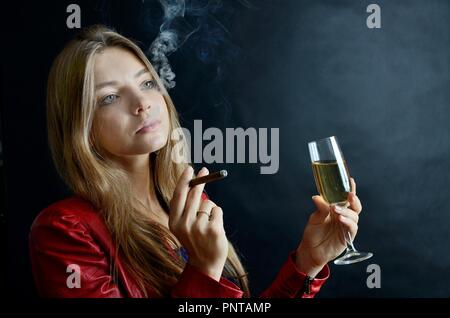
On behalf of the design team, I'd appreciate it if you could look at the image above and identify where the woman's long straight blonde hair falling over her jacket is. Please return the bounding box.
[47,26,250,296]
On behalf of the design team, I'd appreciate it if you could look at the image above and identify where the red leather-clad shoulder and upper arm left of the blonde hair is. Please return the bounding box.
[28,197,121,297]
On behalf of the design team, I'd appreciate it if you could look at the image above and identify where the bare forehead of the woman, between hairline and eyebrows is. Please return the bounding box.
[94,47,146,84]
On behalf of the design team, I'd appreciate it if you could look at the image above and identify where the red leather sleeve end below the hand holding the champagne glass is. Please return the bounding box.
[260,251,330,298]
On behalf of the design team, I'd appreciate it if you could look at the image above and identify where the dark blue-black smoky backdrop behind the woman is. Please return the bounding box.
[1,0,450,297]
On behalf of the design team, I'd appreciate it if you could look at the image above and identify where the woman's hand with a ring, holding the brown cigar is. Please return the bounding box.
[169,166,228,281]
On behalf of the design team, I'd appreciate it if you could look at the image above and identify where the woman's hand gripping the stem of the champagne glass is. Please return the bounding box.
[296,178,362,277]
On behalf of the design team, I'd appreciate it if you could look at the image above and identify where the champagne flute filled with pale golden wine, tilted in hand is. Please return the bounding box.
[308,136,373,265]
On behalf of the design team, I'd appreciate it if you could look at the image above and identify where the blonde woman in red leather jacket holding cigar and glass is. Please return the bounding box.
[30,26,361,297]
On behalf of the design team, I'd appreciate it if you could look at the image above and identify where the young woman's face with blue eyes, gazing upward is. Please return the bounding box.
[93,47,169,157]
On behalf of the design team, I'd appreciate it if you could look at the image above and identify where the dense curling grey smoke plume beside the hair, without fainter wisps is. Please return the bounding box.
[148,0,197,89]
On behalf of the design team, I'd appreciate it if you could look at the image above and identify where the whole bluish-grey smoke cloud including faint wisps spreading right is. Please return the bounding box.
[147,0,253,89]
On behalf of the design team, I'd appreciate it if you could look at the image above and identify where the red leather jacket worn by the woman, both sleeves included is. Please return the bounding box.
[29,194,329,298]
